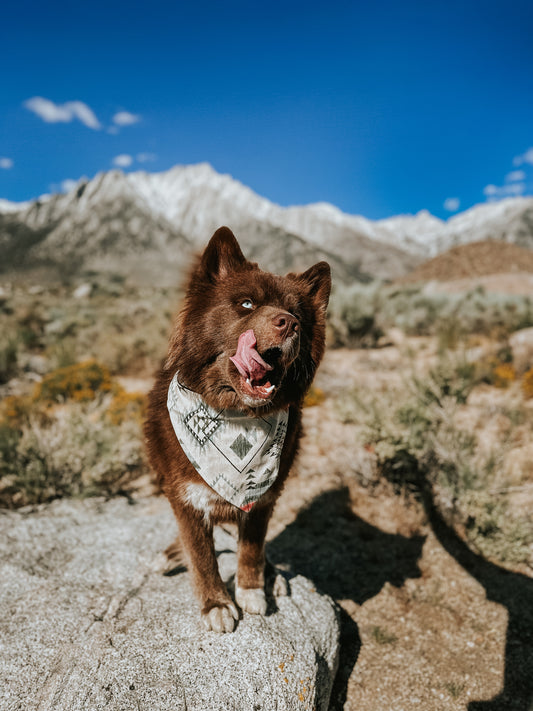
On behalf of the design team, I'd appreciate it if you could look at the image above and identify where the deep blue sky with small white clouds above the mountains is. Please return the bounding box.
[0,0,533,219]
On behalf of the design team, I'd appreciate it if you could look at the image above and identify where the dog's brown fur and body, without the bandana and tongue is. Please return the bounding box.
[145,227,331,632]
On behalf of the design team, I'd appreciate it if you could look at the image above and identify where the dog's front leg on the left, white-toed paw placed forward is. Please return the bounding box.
[176,507,239,632]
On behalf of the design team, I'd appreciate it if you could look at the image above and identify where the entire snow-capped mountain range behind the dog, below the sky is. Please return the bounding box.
[0,163,533,283]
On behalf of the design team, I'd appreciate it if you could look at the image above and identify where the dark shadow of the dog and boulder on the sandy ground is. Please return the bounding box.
[267,487,425,711]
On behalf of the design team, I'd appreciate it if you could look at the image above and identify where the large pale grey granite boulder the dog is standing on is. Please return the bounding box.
[0,498,339,711]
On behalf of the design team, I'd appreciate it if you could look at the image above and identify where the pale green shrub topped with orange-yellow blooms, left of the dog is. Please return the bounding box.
[0,362,147,507]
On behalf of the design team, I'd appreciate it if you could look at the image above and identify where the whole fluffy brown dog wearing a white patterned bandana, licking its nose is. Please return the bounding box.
[145,227,331,632]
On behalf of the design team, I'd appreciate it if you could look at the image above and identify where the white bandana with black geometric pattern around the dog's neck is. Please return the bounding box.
[167,373,288,511]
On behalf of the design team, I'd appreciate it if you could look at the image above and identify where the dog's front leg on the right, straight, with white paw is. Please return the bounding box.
[235,505,272,615]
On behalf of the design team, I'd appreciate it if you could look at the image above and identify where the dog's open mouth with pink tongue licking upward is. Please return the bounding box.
[230,329,281,401]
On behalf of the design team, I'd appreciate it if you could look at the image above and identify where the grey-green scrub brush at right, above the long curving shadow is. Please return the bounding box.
[338,348,533,567]
